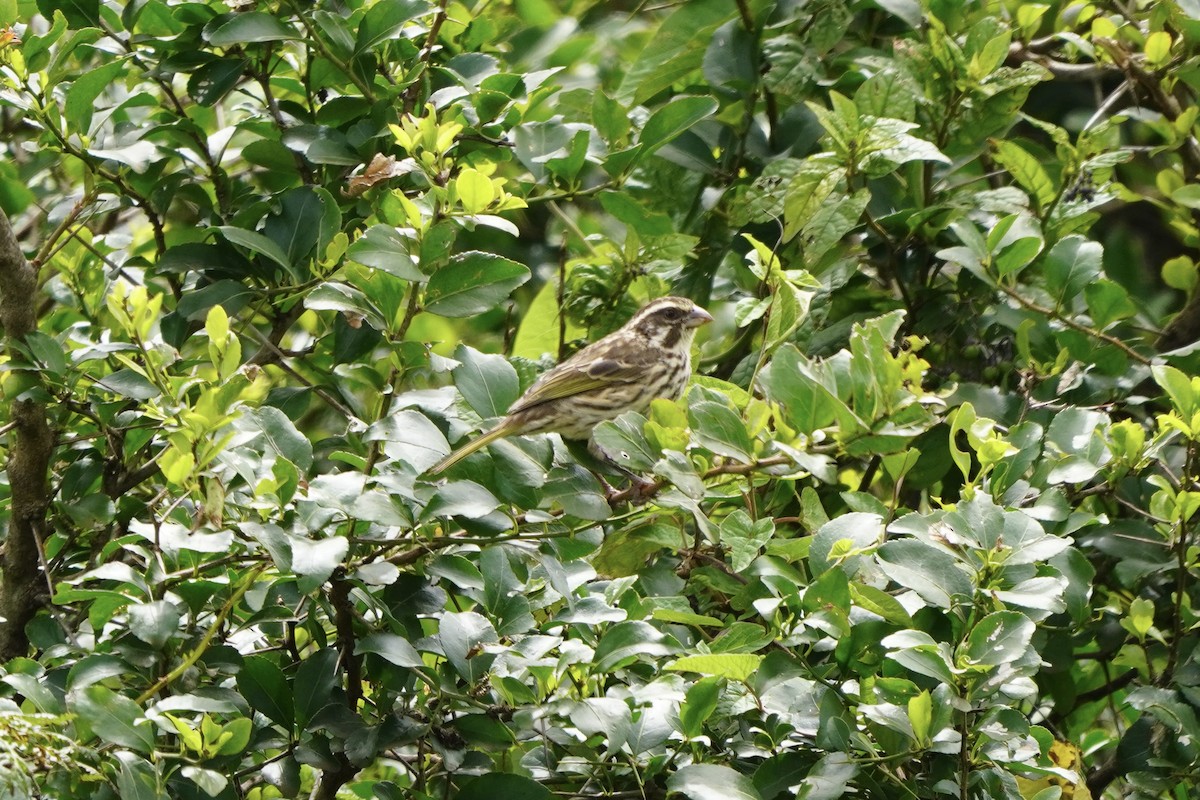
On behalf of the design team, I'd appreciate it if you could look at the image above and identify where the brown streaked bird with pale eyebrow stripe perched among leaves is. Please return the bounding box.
[430,297,713,474]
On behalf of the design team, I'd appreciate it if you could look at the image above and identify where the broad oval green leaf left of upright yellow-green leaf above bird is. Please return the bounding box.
[425,251,529,317]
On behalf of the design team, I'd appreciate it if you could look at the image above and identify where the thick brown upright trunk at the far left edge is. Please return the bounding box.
[0,211,54,662]
